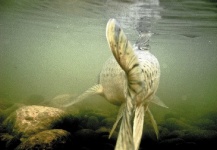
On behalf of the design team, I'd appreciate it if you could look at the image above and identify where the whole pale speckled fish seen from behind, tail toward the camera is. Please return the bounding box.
[64,19,167,150]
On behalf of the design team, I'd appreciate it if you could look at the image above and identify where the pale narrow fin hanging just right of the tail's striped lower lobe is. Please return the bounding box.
[133,104,145,150]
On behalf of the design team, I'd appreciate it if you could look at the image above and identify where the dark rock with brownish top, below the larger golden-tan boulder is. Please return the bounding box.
[16,129,71,150]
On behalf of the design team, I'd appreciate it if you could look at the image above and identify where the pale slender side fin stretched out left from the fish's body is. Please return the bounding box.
[63,84,103,107]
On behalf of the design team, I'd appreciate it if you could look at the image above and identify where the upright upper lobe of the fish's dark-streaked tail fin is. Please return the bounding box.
[106,19,144,94]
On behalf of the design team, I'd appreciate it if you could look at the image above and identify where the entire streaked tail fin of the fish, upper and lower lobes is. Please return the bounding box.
[106,19,145,150]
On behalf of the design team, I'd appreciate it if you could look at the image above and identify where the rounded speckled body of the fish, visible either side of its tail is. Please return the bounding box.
[99,47,160,105]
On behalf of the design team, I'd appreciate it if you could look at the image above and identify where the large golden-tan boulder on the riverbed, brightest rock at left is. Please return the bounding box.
[3,105,65,140]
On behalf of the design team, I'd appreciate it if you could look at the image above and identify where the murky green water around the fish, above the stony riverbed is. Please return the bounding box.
[0,0,217,129]
